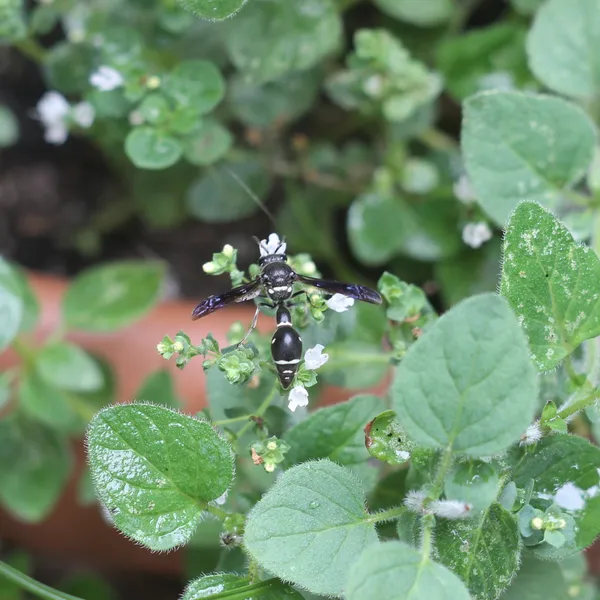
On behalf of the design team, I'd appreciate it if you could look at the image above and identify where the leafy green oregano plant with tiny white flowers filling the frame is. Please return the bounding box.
[0,0,600,600]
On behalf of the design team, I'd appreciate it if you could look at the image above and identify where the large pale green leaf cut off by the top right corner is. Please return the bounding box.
[527,0,600,100]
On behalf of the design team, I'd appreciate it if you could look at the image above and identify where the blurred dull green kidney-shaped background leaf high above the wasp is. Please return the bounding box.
[228,71,319,127]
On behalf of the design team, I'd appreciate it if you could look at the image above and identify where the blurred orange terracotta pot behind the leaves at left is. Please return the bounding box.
[0,274,387,573]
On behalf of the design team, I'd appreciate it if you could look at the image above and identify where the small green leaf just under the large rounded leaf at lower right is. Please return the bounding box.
[444,460,499,514]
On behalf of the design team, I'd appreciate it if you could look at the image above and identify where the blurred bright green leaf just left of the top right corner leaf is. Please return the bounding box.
[436,23,531,100]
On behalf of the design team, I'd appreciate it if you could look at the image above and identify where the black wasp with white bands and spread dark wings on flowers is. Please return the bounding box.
[192,234,381,389]
